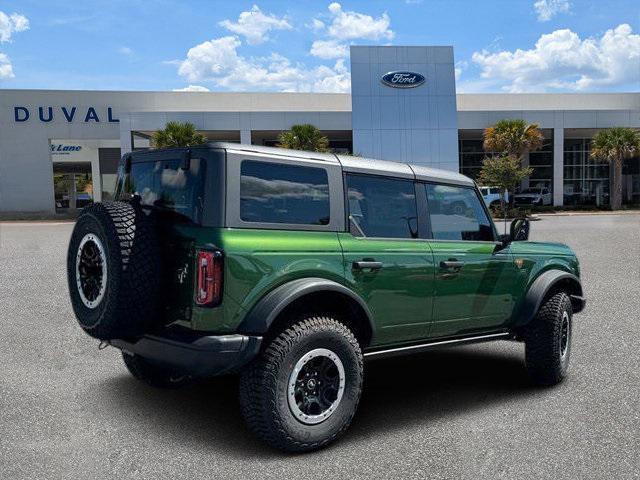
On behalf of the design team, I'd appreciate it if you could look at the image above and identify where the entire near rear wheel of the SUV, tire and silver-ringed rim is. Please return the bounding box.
[240,316,363,452]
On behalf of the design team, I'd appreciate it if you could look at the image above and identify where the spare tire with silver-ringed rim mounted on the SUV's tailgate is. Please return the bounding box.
[67,202,160,340]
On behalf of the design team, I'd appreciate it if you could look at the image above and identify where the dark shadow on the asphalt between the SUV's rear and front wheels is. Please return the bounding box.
[348,342,535,440]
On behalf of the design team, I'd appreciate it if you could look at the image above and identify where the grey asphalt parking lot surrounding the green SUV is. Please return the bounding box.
[0,215,640,479]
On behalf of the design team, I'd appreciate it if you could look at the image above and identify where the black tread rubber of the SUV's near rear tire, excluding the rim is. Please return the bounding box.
[240,316,363,452]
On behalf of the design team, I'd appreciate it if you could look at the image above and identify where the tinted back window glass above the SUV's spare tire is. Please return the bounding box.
[118,158,206,223]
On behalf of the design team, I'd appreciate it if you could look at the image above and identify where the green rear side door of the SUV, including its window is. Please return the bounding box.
[339,174,435,345]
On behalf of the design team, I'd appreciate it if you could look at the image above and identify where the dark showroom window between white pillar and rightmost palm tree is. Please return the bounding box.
[564,138,609,206]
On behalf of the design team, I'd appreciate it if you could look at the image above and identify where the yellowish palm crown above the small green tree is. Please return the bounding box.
[483,119,544,160]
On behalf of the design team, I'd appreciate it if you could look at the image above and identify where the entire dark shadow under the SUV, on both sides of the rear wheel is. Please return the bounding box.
[100,346,534,458]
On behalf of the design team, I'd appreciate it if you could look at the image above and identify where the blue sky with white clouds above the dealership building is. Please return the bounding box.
[0,0,640,92]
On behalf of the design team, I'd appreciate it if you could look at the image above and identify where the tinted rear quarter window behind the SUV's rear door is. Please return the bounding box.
[240,160,329,225]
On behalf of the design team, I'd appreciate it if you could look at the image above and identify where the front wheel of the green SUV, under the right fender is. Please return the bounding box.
[524,292,573,386]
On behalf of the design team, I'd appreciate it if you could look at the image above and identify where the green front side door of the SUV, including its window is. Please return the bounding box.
[426,184,517,337]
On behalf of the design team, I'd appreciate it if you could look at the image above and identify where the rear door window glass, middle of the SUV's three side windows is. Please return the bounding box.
[347,175,418,238]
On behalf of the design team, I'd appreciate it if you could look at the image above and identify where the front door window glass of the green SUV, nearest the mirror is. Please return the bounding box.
[427,184,494,241]
